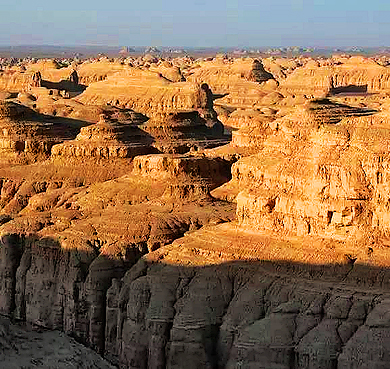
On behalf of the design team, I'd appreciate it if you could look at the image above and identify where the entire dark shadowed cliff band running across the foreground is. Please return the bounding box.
[0,232,390,369]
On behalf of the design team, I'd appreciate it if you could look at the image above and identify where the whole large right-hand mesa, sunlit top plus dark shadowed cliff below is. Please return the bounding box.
[100,100,390,369]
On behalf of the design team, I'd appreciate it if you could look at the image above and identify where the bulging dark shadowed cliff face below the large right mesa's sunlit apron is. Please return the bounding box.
[106,253,390,369]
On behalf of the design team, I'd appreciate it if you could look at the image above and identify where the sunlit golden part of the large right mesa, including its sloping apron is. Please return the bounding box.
[159,99,390,266]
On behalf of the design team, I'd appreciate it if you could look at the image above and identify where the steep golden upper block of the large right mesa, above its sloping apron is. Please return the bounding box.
[229,100,387,247]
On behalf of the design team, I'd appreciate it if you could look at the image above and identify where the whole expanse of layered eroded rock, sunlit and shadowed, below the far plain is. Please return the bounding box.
[0,56,390,369]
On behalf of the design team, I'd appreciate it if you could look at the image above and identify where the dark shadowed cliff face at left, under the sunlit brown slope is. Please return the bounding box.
[0,234,135,352]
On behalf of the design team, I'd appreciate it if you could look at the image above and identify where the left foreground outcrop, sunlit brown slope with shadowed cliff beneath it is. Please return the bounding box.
[0,144,234,362]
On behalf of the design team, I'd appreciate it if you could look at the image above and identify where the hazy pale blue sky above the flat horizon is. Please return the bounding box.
[0,0,390,47]
